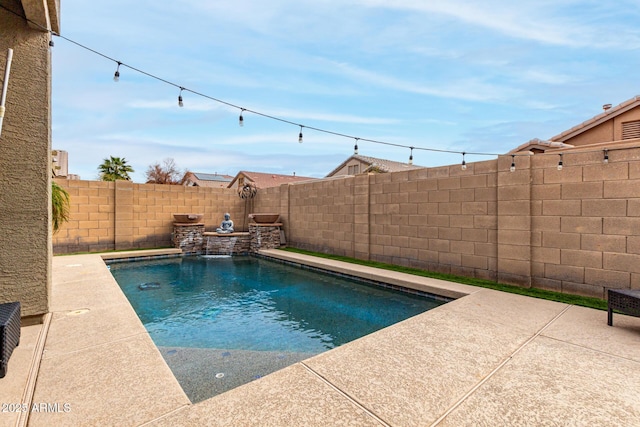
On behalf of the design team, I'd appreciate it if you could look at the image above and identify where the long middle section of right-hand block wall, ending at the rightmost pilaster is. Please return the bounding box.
[288,161,497,279]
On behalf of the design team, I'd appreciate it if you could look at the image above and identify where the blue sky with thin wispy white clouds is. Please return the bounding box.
[51,0,640,183]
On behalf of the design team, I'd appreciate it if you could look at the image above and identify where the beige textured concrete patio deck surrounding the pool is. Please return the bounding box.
[0,251,640,427]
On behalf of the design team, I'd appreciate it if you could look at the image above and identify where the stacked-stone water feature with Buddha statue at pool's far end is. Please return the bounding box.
[172,214,282,255]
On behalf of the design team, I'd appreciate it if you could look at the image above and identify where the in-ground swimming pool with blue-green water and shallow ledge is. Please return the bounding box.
[110,256,444,402]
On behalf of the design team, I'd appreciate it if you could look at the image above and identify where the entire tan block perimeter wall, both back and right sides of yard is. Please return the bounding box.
[56,140,640,298]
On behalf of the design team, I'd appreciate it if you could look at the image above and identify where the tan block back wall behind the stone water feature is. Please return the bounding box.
[53,179,248,254]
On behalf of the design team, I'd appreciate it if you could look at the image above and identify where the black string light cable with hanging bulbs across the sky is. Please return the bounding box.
[0,4,637,170]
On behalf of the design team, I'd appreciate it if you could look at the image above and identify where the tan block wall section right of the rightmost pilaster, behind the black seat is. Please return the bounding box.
[531,148,640,298]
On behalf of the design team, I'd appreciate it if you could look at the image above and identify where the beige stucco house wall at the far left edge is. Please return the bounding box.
[0,0,57,316]
